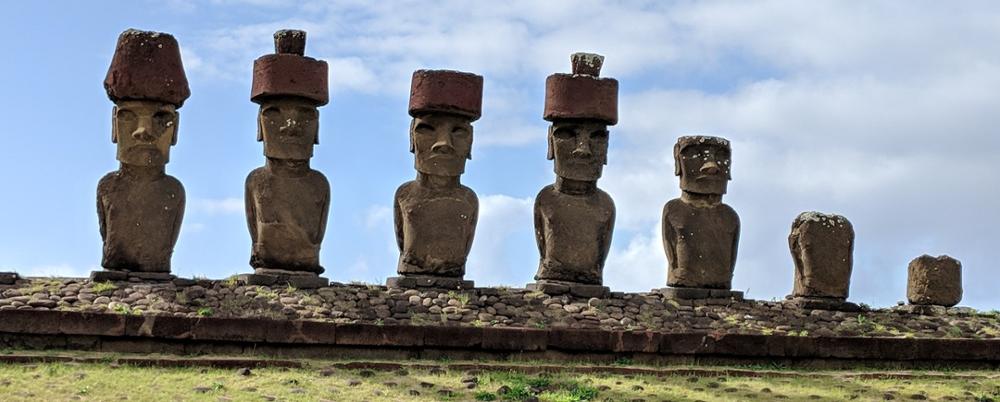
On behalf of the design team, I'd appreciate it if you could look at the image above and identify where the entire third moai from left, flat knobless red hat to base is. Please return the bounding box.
[386,70,483,289]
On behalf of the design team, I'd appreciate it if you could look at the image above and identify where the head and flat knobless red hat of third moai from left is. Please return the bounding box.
[409,70,483,176]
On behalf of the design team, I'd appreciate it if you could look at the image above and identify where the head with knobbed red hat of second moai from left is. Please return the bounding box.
[250,30,329,160]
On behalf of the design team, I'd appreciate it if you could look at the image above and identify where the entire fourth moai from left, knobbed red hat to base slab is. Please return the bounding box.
[528,53,618,297]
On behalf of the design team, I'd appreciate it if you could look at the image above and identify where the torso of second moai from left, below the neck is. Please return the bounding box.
[246,167,330,273]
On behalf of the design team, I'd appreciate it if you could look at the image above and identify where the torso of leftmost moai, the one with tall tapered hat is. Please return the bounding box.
[97,171,184,272]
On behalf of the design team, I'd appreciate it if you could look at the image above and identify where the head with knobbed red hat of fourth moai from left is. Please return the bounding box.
[542,53,618,181]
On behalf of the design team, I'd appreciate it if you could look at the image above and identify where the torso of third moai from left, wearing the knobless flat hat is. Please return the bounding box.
[394,181,479,277]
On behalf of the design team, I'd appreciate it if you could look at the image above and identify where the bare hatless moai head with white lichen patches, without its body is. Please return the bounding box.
[674,135,733,195]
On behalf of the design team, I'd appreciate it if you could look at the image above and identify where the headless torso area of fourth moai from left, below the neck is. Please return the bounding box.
[535,185,615,285]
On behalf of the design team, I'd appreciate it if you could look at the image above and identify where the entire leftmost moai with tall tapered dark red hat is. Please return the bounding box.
[91,29,191,281]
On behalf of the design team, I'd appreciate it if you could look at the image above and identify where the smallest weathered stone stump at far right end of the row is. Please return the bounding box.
[906,255,962,307]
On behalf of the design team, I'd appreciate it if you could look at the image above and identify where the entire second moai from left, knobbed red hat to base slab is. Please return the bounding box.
[240,30,330,288]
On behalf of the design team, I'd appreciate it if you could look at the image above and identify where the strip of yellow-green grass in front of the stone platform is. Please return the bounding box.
[0,358,1000,402]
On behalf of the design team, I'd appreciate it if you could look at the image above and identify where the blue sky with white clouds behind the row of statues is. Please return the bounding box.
[0,0,1000,309]
